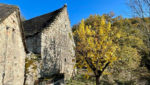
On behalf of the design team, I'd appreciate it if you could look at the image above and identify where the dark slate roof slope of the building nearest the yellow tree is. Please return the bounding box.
[23,5,66,37]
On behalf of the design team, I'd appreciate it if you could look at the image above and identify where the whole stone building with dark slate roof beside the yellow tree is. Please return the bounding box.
[24,6,75,79]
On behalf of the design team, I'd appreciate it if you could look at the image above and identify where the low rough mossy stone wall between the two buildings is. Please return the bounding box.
[25,53,42,85]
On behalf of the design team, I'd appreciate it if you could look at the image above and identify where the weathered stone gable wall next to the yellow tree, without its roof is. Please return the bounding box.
[41,7,75,79]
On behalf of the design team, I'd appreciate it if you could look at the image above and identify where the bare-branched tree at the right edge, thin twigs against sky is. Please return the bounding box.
[128,0,150,69]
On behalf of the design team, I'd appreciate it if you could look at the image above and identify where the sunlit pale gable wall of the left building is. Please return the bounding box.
[0,11,26,85]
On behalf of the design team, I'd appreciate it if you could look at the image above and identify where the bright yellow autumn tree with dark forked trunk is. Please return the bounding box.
[74,16,120,85]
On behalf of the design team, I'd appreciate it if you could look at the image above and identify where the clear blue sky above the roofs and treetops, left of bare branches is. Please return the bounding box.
[0,0,130,25]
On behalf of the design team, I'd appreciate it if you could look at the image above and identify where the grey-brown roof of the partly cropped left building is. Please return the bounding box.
[0,3,19,23]
